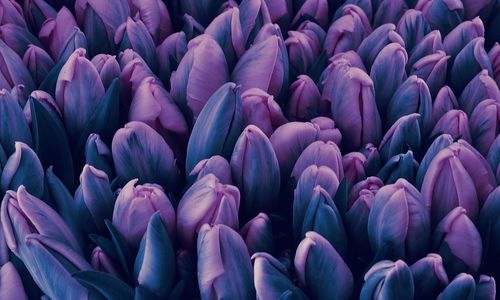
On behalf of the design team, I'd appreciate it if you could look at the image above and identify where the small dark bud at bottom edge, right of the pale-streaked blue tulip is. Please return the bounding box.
[410,253,448,299]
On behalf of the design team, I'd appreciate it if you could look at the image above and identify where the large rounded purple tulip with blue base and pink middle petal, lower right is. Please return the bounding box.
[368,179,431,262]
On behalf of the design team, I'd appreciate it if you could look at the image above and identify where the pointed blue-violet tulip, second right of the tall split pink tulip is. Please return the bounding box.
[387,75,432,136]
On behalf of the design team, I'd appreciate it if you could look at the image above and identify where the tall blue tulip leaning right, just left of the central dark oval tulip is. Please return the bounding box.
[186,83,243,174]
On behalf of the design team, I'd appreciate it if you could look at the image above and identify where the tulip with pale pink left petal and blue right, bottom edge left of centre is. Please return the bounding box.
[197,224,255,300]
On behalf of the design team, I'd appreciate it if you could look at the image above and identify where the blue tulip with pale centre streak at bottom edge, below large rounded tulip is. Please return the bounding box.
[360,260,415,300]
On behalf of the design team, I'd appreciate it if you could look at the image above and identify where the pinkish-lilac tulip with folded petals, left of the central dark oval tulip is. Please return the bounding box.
[177,174,240,253]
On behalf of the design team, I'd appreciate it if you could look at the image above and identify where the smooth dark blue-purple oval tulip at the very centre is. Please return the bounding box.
[230,125,280,216]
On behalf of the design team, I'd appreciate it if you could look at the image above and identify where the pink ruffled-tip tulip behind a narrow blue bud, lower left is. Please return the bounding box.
[113,179,176,248]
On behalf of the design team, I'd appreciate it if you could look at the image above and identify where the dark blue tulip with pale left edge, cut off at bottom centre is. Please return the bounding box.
[252,252,307,300]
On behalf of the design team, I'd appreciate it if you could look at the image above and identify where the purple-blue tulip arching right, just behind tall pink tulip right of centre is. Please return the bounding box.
[357,24,405,69]
